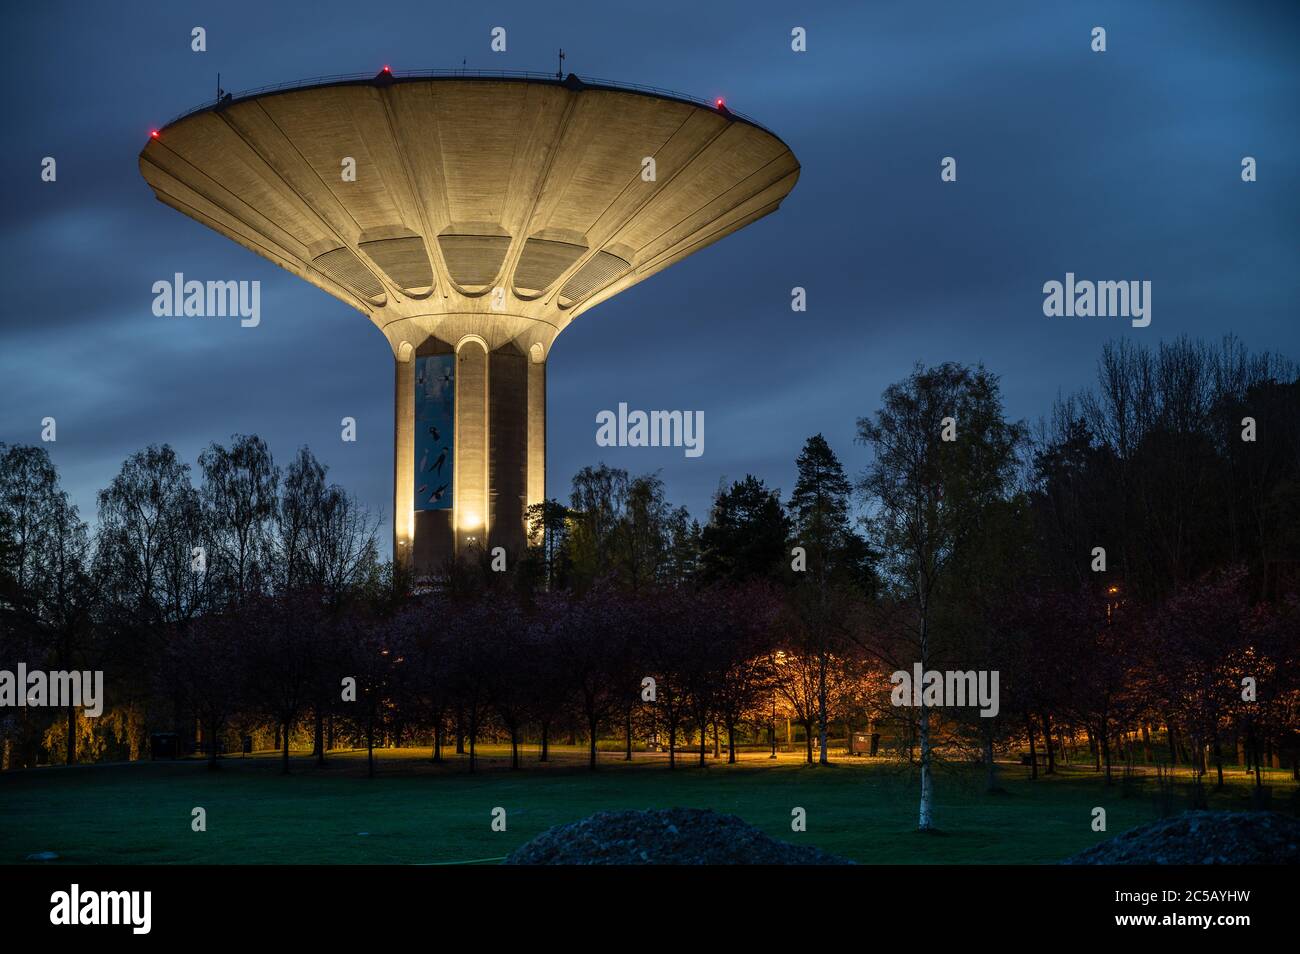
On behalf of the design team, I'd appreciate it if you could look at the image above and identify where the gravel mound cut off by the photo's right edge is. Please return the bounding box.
[1061,811,1300,864]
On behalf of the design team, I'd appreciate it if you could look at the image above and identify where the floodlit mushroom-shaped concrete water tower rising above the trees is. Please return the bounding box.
[140,69,800,574]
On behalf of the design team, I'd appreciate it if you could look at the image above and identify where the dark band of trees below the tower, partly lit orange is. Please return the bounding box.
[0,338,1300,828]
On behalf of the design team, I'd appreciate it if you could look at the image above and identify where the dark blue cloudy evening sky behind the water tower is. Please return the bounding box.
[0,0,1300,554]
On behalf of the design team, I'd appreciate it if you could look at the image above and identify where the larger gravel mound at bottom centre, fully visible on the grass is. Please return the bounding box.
[506,808,853,864]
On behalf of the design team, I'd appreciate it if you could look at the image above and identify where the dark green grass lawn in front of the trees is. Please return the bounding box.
[0,746,1295,864]
